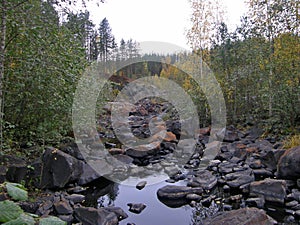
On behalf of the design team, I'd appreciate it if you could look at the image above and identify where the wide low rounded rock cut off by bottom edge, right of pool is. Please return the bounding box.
[203,208,277,225]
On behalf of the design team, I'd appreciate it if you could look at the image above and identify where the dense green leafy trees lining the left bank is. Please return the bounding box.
[3,0,87,147]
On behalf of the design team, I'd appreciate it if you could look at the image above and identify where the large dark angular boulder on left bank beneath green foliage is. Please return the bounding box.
[40,147,82,189]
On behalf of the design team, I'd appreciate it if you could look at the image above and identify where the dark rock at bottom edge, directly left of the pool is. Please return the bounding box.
[74,207,119,225]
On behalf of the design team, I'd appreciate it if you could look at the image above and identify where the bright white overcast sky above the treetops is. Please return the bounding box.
[87,0,246,49]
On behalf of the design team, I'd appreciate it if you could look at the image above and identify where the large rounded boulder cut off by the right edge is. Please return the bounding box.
[277,146,300,179]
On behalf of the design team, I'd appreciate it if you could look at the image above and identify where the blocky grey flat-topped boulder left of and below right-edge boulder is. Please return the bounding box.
[250,178,287,204]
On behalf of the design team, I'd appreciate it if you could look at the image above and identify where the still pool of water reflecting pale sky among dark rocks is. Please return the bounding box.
[87,178,205,225]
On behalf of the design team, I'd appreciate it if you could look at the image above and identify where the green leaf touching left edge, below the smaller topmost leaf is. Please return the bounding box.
[0,200,23,223]
